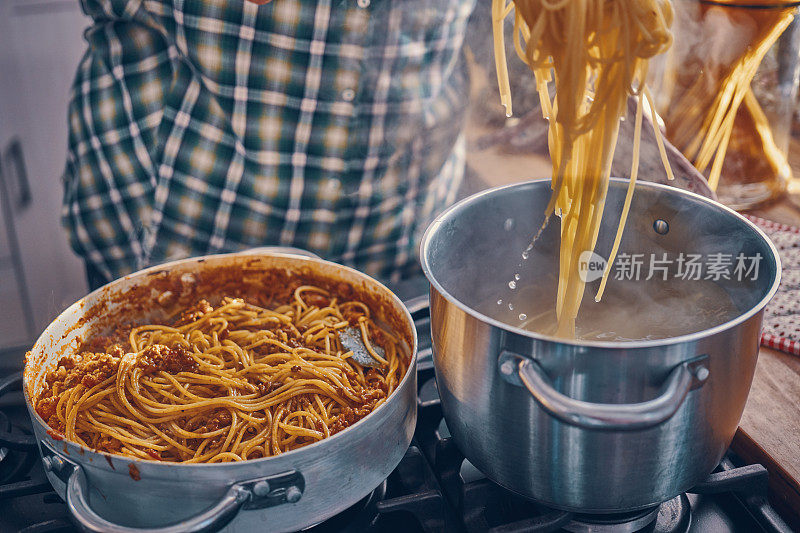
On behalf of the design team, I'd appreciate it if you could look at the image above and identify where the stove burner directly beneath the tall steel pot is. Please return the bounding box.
[563,494,691,533]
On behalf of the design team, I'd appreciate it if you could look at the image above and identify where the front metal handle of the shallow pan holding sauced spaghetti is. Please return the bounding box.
[41,442,305,533]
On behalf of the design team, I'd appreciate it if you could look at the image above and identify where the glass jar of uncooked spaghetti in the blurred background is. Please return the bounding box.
[650,0,800,209]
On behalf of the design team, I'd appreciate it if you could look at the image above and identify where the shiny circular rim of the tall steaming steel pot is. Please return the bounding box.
[420,178,781,350]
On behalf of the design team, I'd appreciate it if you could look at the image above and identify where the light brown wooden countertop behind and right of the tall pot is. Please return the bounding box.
[466,115,800,531]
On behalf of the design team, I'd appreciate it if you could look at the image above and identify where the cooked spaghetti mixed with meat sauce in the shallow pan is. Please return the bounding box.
[35,285,408,463]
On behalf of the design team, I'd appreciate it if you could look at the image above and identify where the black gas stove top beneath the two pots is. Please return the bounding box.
[0,294,792,533]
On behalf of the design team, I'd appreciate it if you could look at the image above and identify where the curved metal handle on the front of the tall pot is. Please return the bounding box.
[498,350,708,431]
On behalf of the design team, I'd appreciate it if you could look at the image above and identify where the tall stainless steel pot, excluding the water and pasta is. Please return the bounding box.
[422,180,780,513]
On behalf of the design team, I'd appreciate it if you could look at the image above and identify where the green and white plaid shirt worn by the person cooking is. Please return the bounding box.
[63,0,474,280]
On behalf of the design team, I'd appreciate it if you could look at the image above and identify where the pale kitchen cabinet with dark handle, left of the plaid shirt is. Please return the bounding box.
[0,0,89,351]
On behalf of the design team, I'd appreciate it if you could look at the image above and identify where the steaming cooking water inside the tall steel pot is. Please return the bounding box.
[487,280,741,341]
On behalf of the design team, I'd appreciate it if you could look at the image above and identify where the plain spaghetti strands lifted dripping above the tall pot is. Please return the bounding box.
[492,0,673,336]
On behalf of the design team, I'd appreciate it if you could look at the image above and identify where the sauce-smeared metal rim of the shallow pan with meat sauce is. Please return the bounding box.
[22,251,418,469]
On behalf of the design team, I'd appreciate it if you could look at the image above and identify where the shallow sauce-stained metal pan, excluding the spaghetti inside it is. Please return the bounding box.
[24,252,417,532]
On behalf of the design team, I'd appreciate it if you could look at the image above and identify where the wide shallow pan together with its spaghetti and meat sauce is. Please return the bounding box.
[24,251,416,531]
